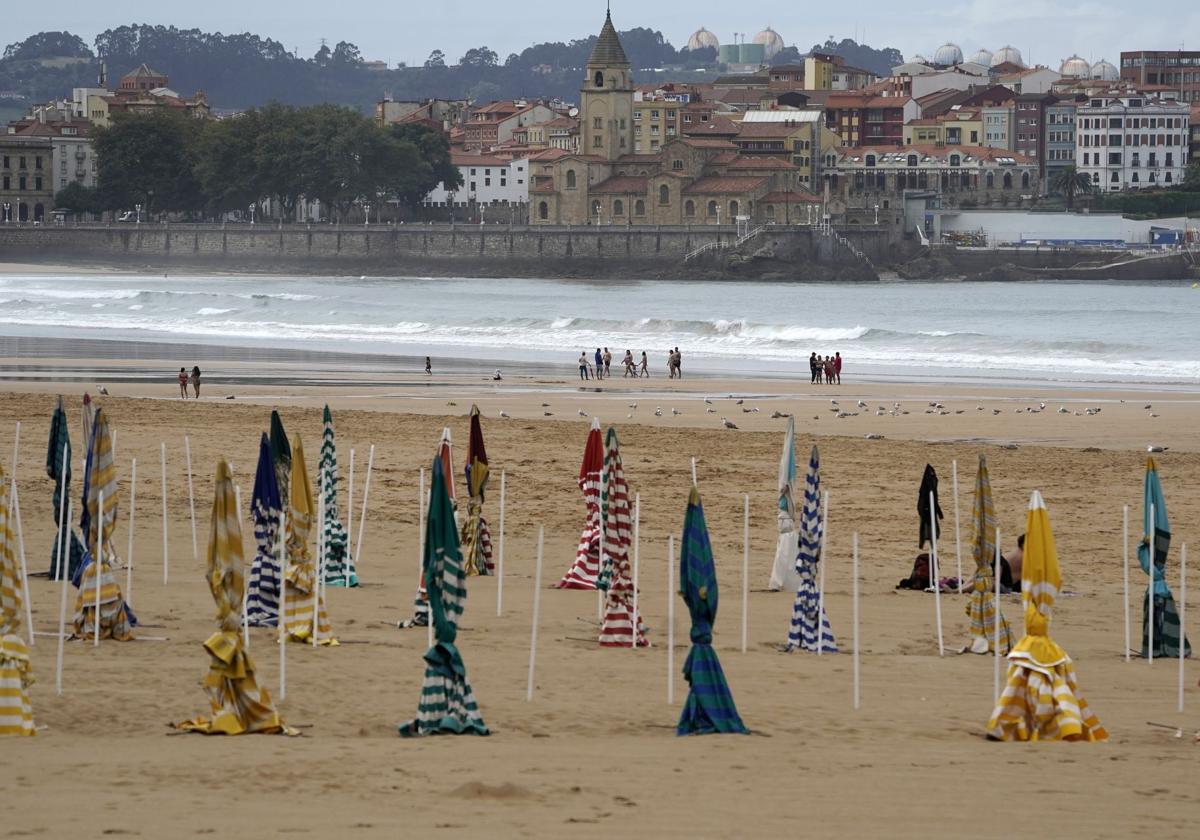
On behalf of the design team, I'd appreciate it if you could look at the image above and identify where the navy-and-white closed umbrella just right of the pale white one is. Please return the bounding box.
[786,446,838,653]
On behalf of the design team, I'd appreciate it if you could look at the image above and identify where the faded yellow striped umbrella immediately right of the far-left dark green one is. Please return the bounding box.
[74,409,137,642]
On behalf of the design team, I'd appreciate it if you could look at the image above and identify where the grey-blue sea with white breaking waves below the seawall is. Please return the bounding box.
[0,274,1200,385]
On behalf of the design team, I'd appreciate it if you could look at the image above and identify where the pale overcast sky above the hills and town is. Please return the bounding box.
[11,0,1200,71]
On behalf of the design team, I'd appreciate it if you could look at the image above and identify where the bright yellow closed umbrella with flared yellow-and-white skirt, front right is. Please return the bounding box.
[988,491,1109,740]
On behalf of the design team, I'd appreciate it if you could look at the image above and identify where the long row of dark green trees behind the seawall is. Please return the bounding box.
[55,103,461,221]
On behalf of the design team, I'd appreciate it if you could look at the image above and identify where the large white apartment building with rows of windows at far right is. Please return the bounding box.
[1075,94,1190,192]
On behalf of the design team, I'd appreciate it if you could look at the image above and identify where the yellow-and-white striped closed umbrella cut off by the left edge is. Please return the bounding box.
[0,467,36,736]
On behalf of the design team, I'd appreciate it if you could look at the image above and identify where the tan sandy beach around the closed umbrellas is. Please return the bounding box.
[0,374,1200,839]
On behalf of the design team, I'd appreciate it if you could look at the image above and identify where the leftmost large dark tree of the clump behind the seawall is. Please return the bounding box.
[94,110,204,216]
